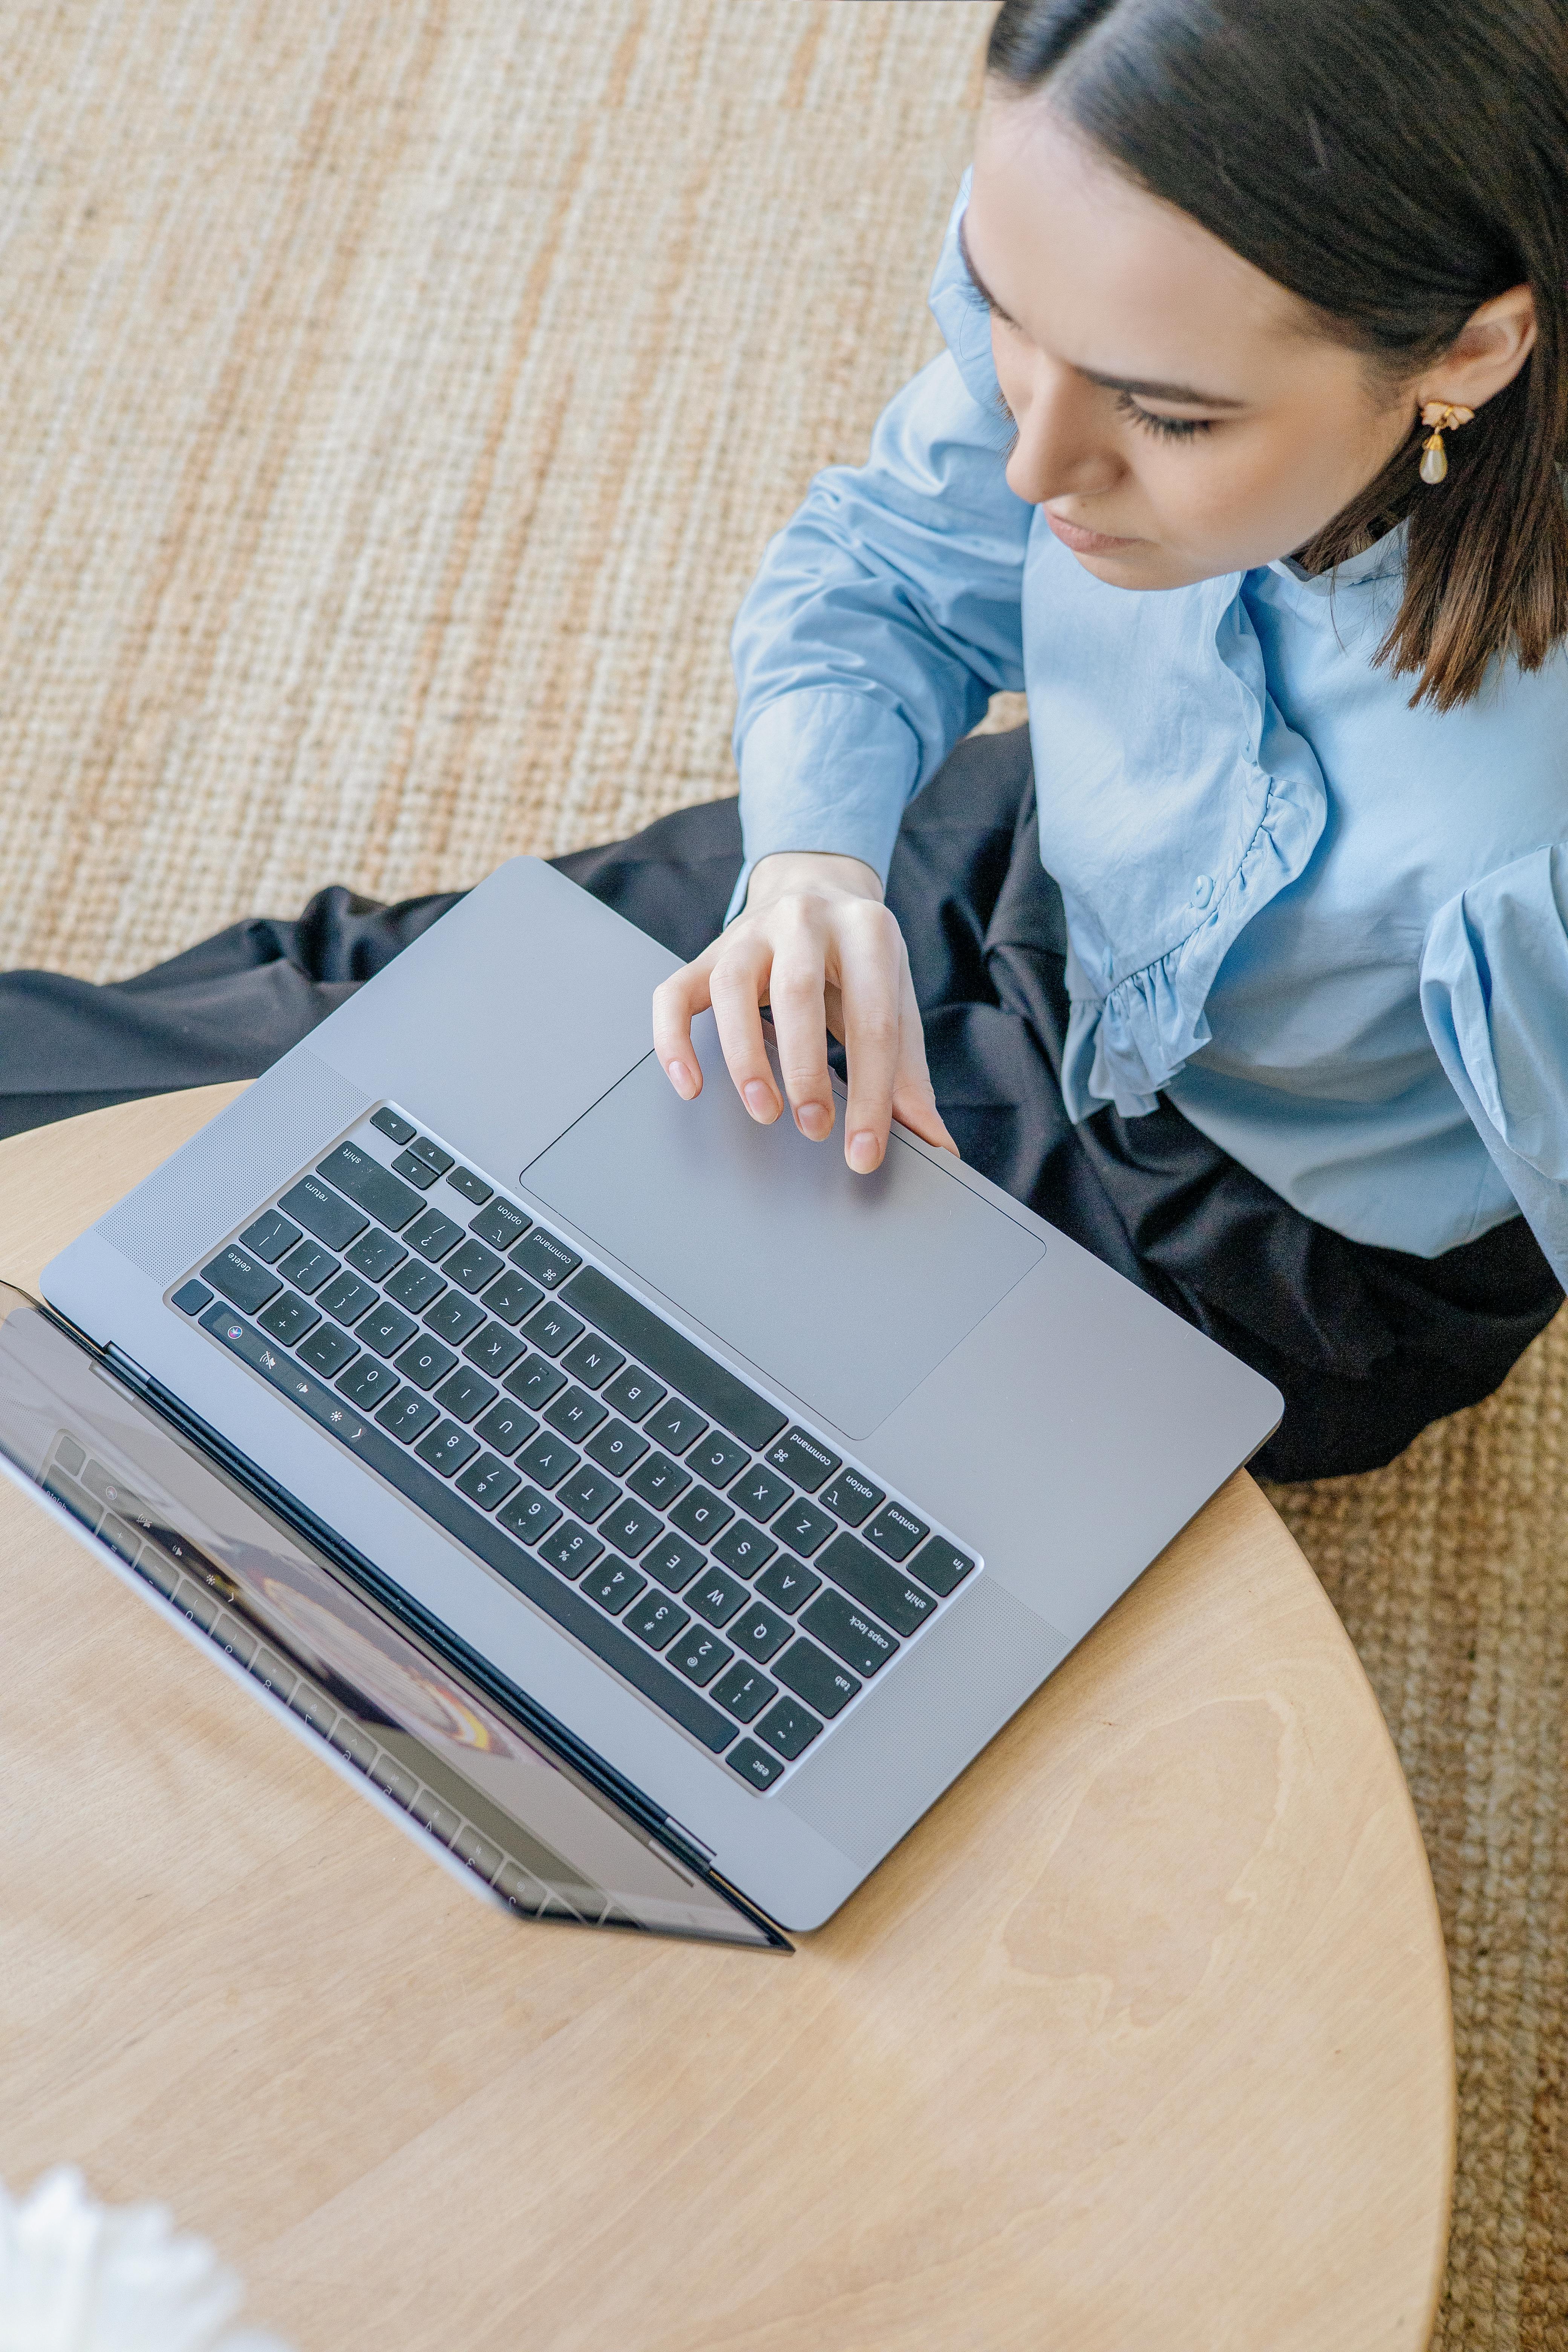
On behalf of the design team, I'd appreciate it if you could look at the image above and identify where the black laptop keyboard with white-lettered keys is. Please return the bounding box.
[167,1106,978,1792]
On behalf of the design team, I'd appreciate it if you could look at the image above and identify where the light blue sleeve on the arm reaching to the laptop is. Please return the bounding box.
[731,165,1034,913]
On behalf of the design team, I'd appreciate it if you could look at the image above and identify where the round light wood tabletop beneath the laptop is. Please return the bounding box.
[0,1087,1453,2352]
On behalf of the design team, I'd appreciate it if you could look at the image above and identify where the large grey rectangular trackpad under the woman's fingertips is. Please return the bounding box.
[524,1021,1044,1437]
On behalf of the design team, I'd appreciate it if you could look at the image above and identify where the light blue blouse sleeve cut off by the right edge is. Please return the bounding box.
[1420,842,1568,1284]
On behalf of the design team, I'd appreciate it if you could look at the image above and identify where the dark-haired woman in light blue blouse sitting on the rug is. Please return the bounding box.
[12,0,1568,1477]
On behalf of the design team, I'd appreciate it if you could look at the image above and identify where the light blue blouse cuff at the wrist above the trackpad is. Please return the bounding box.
[724,687,919,922]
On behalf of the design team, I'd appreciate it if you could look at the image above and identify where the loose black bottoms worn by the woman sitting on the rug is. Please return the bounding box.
[0,729,1563,1479]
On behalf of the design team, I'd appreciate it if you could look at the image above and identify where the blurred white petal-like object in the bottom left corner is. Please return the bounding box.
[0,2166,289,2352]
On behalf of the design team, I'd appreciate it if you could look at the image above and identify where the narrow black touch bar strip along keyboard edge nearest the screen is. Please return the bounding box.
[202,1308,736,1755]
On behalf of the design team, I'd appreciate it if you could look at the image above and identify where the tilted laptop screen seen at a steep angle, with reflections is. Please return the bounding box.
[0,1284,787,1950]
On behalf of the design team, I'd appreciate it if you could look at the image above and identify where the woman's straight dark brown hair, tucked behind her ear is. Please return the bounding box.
[987,0,1568,710]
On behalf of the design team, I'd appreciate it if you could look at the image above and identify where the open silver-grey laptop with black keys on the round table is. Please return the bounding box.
[15,859,1281,1945]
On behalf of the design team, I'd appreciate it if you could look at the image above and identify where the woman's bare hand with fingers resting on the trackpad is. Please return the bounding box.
[654,851,957,1176]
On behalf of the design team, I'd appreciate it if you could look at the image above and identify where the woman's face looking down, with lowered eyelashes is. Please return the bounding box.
[964,92,1415,588]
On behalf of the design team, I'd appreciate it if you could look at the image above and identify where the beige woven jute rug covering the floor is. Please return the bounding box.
[0,0,1568,2352]
